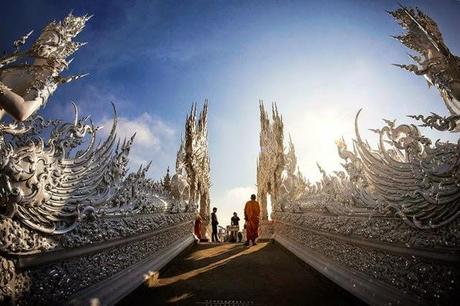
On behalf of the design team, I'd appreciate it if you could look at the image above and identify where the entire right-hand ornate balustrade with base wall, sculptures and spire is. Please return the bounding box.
[257,8,460,305]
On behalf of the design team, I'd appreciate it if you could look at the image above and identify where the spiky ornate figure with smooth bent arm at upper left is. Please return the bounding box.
[0,13,92,121]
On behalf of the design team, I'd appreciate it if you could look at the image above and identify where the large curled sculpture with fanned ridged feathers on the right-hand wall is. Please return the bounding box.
[356,109,460,229]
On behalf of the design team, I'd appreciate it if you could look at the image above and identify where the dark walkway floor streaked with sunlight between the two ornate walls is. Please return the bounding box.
[119,243,365,306]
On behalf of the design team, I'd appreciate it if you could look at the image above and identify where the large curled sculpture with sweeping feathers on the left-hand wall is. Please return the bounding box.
[0,107,133,239]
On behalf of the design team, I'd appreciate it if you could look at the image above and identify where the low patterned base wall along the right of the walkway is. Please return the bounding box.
[274,212,460,305]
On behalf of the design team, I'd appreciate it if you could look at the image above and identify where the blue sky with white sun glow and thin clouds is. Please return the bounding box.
[0,0,460,224]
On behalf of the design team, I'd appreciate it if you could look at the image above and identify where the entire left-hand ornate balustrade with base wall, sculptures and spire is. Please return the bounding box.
[0,14,209,305]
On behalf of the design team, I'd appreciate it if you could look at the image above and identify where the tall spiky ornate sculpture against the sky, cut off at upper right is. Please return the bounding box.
[389,6,460,131]
